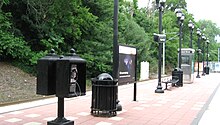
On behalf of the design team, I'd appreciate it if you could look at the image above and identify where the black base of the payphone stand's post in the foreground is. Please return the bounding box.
[47,118,74,125]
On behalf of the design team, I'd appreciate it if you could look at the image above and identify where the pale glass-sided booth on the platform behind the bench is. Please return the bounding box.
[181,48,195,83]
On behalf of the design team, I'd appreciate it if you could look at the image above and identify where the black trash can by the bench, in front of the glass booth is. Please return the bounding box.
[172,68,183,87]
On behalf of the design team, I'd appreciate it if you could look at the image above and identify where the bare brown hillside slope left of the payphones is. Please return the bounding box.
[0,62,42,106]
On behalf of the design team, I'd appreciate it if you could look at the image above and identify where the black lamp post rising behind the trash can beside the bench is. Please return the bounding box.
[176,9,185,69]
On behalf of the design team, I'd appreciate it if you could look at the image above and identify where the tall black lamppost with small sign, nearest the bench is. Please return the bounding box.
[155,0,166,93]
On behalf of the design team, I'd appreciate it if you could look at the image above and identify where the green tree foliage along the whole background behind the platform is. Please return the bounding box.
[0,0,220,77]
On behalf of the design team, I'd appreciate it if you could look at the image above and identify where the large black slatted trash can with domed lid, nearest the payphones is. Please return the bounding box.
[91,73,118,117]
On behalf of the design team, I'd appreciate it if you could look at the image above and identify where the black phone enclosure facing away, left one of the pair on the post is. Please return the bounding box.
[37,49,59,95]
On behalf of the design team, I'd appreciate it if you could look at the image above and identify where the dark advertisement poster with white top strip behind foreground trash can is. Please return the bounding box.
[118,45,137,84]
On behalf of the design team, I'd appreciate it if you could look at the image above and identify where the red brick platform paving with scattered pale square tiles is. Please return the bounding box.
[0,74,219,125]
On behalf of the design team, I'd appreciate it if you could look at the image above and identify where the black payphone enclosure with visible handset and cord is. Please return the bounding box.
[56,49,86,98]
